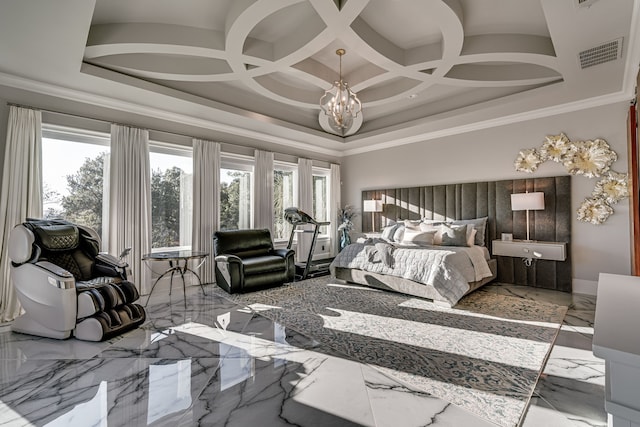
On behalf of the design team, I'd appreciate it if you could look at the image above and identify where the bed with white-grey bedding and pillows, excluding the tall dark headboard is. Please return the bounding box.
[330,221,497,307]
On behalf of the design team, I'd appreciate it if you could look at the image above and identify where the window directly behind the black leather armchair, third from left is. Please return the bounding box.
[220,155,253,230]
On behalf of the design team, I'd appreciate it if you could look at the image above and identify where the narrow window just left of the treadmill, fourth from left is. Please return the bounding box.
[273,162,298,240]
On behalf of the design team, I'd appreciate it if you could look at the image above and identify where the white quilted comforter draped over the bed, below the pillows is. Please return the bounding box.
[330,242,492,304]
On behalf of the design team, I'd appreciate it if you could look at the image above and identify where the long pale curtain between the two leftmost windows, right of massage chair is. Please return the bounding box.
[109,124,151,294]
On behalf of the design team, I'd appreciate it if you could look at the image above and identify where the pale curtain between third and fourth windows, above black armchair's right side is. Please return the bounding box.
[253,150,273,233]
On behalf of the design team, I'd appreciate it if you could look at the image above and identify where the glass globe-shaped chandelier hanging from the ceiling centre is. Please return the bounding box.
[320,49,362,136]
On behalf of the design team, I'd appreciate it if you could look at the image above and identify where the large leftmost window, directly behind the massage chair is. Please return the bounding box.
[42,125,110,250]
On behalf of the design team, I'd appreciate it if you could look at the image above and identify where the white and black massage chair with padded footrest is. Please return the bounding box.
[9,219,146,341]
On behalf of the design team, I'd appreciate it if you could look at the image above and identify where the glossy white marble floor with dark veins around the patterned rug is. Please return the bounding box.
[0,284,606,427]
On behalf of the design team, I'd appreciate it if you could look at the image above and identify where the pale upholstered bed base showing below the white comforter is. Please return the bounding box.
[335,259,498,307]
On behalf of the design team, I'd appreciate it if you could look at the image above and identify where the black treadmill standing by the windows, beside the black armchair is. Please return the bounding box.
[284,207,333,280]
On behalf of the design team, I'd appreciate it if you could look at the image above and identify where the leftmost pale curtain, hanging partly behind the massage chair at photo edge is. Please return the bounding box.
[0,106,42,322]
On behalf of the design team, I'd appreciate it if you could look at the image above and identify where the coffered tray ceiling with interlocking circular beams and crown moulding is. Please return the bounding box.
[0,0,639,155]
